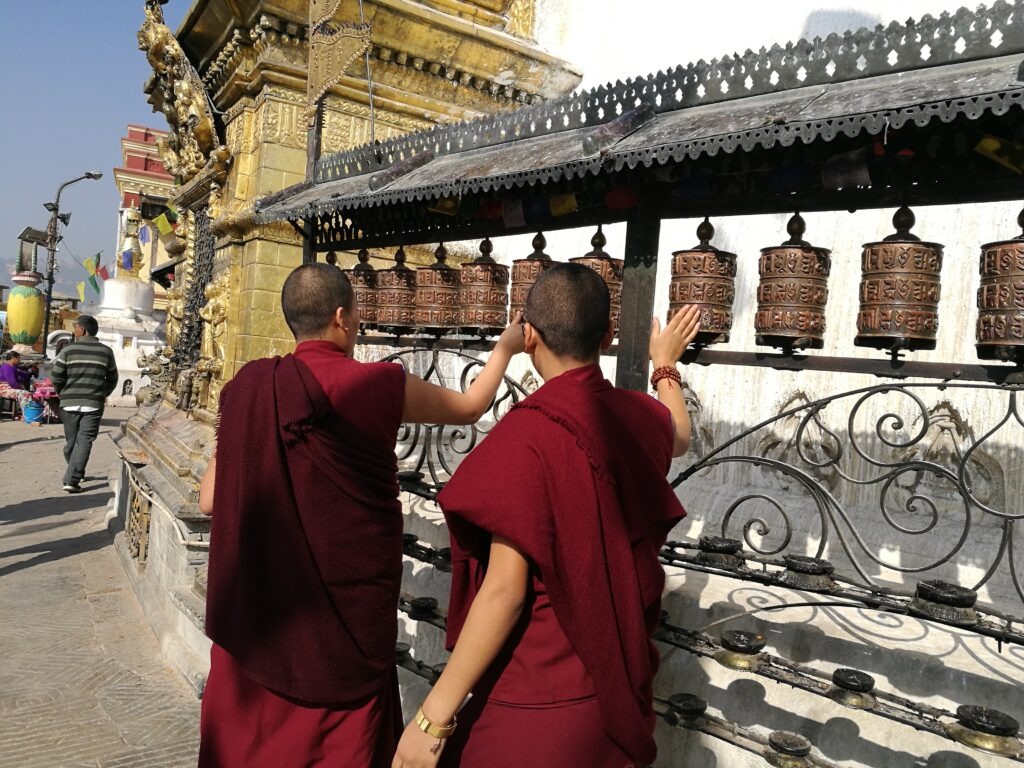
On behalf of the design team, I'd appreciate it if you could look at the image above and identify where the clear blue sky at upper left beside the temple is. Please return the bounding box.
[0,0,189,300]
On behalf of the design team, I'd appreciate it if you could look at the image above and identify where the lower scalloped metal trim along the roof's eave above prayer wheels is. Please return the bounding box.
[257,86,1024,223]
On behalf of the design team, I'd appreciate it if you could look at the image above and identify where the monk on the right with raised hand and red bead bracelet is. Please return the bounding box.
[392,264,698,768]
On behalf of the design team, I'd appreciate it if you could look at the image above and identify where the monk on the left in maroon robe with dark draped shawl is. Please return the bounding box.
[199,264,523,768]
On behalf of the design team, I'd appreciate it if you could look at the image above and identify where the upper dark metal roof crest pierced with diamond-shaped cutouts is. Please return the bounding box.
[316,0,1024,182]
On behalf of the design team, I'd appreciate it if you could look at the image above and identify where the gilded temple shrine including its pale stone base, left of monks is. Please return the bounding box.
[112,0,580,690]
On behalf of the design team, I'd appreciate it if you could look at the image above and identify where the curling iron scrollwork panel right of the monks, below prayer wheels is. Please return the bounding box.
[673,382,1024,614]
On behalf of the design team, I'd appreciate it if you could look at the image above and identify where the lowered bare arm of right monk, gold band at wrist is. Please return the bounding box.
[391,536,529,768]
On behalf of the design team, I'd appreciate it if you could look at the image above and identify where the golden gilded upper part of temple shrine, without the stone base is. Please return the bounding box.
[139,0,580,422]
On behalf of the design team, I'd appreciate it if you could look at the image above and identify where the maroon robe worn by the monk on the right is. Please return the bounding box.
[438,366,685,768]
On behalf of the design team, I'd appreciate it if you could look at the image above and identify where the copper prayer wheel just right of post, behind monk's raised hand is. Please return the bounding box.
[668,218,736,345]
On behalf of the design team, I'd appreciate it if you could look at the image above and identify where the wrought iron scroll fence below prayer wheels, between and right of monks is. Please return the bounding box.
[378,348,1024,618]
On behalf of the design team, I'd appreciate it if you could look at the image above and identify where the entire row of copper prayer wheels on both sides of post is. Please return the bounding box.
[339,202,1024,361]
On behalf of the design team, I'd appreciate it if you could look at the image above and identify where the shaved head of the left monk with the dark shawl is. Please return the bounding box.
[281,263,355,339]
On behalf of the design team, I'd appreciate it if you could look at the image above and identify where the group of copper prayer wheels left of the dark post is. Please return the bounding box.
[342,227,623,336]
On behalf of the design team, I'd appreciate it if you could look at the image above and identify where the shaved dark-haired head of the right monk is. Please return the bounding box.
[524,263,611,360]
